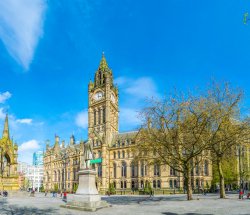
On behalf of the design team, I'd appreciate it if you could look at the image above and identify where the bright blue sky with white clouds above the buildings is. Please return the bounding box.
[0,0,250,162]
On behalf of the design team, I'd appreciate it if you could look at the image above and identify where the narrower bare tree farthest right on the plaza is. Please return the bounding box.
[206,83,249,198]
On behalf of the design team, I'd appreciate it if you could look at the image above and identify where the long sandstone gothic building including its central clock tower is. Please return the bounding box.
[44,55,212,193]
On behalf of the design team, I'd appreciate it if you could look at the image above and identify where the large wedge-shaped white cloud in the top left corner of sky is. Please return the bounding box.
[0,0,46,70]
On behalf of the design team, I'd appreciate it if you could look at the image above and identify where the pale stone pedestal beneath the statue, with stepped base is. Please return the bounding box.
[61,169,110,211]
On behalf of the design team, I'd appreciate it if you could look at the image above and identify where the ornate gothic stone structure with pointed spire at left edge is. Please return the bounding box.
[0,115,19,190]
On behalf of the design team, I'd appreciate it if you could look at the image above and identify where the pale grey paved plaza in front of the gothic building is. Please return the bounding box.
[0,194,250,215]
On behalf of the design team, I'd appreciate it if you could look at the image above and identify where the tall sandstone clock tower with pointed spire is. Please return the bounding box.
[88,54,119,190]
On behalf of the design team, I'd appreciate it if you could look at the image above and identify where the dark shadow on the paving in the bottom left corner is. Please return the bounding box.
[0,199,59,215]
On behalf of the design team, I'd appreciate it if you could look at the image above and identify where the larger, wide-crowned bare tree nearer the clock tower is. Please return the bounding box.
[135,93,210,200]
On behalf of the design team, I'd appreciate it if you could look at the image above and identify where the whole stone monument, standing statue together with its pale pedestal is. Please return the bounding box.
[62,141,110,211]
